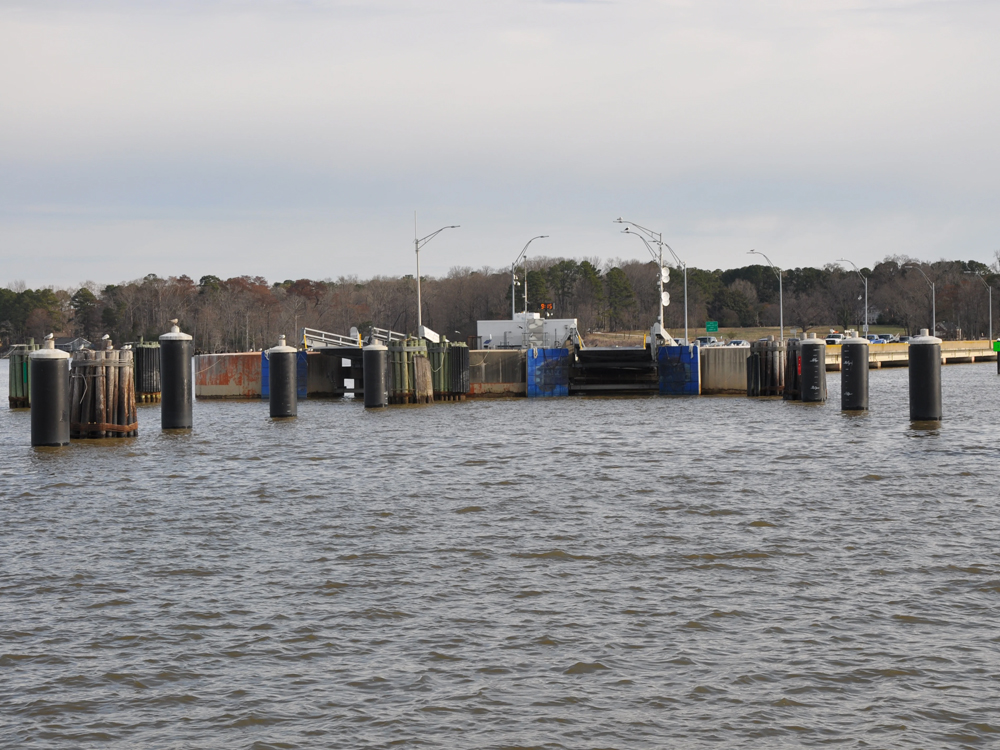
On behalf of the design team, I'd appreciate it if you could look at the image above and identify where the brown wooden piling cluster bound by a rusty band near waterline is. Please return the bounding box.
[70,349,139,439]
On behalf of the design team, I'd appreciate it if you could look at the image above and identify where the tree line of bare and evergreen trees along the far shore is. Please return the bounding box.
[0,253,1000,352]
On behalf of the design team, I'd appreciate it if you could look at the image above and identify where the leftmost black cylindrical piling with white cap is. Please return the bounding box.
[28,338,69,446]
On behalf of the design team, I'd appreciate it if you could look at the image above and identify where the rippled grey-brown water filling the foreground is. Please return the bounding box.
[0,364,1000,749]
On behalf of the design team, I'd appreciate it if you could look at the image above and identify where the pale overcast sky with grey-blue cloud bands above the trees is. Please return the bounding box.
[0,0,1000,286]
